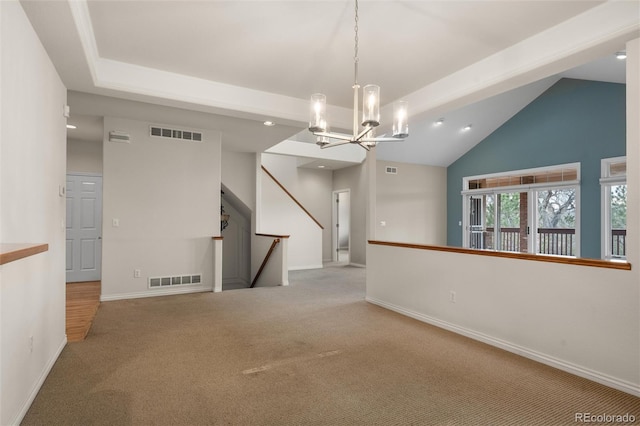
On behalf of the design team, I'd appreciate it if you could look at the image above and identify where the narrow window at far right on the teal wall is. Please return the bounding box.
[600,157,627,260]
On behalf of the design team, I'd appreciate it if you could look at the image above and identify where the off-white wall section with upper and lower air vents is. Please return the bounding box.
[102,117,221,300]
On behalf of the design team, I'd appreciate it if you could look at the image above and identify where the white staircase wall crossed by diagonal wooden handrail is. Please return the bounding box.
[260,154,324,270]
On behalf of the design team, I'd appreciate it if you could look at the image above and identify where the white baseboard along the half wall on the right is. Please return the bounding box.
[365,297,640,397]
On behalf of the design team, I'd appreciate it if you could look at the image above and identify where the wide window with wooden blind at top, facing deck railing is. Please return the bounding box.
[462,164,580,256]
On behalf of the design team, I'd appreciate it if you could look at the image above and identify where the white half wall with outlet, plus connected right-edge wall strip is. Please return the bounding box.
[366,39,640,396]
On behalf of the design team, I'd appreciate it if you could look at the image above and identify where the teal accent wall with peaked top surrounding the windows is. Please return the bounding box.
[447,79,626,258]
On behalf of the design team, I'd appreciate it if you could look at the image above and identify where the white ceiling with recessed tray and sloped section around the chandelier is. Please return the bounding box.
[21,0,640,166]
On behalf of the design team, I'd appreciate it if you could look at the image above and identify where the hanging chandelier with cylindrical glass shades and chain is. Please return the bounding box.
[309,0,409,151]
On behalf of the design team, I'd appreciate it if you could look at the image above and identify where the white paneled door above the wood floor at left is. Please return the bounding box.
[67,174,102,282]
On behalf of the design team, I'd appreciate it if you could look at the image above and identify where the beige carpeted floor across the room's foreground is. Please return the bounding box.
[22,267,640,425]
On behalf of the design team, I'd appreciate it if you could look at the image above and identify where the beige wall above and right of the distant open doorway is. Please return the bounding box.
[333,163,367,265]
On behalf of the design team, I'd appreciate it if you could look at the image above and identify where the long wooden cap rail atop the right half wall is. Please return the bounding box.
[369,240,631,271]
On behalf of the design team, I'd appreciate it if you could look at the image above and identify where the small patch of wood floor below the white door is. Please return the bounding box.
[66,281,101,342]
